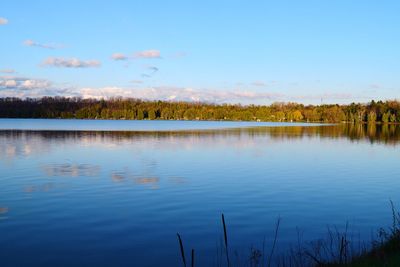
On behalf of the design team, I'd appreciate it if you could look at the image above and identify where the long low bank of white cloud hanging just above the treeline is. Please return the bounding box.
[0,76,362,104]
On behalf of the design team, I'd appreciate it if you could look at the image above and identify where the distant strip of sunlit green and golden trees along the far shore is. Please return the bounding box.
[0,97,400,123]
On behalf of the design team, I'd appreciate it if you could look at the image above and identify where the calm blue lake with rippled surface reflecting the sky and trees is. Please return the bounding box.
[0,119,400,266]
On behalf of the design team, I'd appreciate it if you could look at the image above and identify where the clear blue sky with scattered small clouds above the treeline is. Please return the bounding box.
[0,0,400,104]
